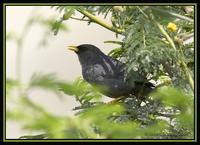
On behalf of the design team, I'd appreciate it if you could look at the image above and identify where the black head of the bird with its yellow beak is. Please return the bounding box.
[68,44,105,65]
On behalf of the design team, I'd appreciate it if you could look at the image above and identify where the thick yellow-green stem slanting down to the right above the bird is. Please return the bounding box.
[77,9,124,34]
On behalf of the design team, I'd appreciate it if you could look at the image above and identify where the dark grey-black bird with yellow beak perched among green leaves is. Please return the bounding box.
[68,44,155,98]
